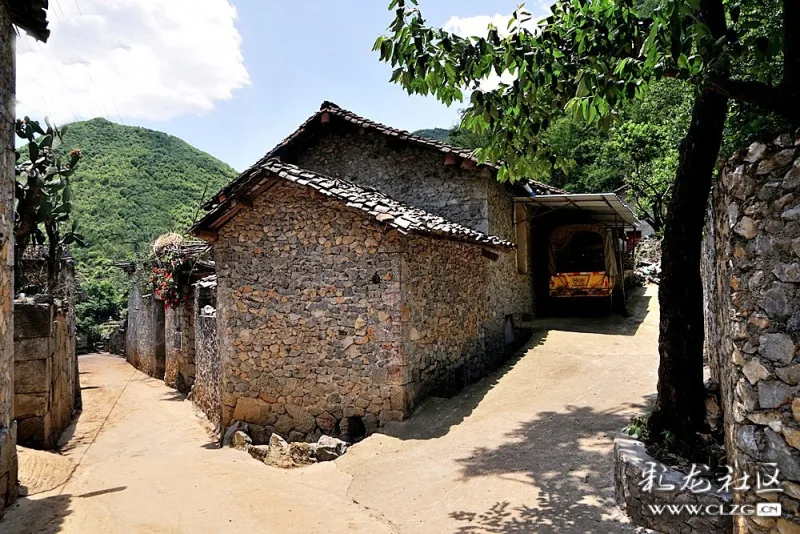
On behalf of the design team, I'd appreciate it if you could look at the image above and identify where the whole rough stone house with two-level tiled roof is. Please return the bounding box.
[191,102,562,439]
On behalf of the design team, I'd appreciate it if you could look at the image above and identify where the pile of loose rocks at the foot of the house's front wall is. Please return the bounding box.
[225,421,348,469]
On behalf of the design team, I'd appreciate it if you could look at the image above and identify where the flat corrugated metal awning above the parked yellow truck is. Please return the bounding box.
[514,193,640,229]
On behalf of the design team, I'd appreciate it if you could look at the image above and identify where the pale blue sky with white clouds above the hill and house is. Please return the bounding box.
[18,0,543,170]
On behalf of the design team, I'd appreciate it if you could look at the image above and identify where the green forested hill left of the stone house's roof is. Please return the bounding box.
[59,119,236,265]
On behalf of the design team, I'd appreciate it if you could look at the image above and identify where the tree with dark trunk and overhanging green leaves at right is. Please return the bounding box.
[375,0,800,455]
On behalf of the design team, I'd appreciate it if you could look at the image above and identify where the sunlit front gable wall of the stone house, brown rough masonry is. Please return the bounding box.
[214,183,403,440]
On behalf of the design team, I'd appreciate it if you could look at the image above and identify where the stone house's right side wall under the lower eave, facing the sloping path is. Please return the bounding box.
[401,237,494,406]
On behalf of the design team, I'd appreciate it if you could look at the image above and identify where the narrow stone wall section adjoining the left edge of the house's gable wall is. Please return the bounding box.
[192,286,222,426]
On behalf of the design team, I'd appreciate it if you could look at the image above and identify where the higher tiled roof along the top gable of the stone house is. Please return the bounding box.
[203,101,566,210]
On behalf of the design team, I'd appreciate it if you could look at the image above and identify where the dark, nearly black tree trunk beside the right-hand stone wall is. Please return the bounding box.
[649,91,728,455]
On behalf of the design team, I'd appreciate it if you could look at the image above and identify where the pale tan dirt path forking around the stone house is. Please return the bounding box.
[0,289,658,534]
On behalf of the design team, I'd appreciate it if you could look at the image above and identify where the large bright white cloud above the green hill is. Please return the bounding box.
[17,0,250,122]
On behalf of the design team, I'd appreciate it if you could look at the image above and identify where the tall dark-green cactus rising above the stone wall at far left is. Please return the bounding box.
[14,117,84,291]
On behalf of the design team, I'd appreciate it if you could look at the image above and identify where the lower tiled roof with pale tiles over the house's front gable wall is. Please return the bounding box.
[190,159,514,247]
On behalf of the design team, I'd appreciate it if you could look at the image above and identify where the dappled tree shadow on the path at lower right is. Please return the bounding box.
[450,404,644,534]
